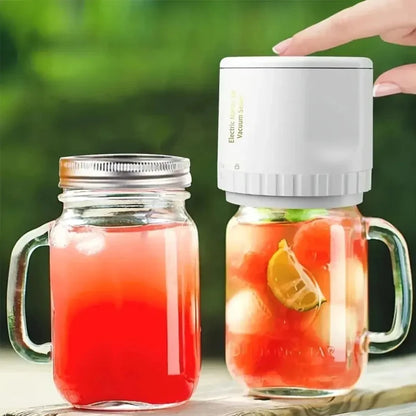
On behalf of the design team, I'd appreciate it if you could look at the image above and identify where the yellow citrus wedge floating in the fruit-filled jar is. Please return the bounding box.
[267,239,326,312]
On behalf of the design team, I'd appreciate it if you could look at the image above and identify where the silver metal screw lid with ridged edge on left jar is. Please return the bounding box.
[59,153,191,189]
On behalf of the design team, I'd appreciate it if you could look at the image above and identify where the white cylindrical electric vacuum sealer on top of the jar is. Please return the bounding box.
[218,57,373,208]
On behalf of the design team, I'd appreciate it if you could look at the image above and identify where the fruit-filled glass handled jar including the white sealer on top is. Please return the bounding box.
[218,57,412,397]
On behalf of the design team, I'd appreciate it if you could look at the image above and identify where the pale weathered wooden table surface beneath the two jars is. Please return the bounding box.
[0,351,416,416]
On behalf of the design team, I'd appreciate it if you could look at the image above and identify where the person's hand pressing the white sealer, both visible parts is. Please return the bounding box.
[273,0,416,97]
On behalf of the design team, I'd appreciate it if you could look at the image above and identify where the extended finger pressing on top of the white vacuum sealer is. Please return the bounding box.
[273,0,416,55]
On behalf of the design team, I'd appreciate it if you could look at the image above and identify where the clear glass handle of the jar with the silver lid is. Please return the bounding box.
[7,222,53,363]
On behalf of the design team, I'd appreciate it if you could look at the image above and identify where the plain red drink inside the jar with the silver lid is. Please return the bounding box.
[50,223,200,406]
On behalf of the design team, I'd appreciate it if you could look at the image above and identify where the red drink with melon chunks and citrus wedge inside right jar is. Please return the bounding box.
[226,213,367,395]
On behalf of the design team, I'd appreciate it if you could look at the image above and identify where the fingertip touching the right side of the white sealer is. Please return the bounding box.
[374,64,416,97]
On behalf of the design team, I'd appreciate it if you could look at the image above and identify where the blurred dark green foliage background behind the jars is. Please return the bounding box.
[0,0,416,356]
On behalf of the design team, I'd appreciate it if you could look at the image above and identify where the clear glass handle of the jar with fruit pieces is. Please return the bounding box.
[365,218,413,354]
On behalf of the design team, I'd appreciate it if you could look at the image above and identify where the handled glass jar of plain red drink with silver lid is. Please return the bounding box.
[8,154,200,410]
